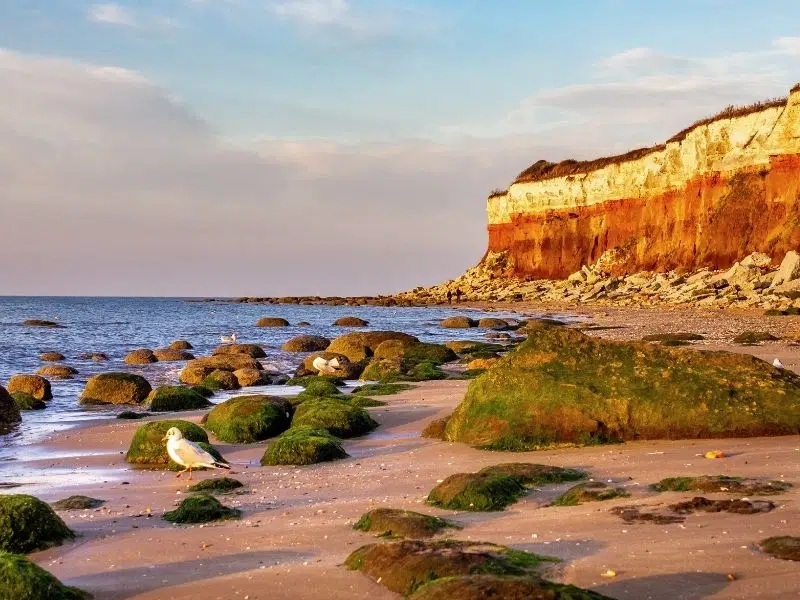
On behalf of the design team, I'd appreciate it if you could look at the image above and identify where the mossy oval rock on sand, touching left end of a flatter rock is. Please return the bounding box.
[428,473,526,512]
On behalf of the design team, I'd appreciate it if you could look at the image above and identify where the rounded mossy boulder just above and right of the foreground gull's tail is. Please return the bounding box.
[206,396,292,444]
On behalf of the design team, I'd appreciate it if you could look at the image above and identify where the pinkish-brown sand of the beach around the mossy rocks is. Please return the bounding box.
[10,309,800,600]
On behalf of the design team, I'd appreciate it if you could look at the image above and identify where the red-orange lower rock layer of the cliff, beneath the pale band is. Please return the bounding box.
[489,154,800,279]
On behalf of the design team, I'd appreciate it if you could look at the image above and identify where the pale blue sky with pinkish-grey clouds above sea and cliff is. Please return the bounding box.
[0,0,800,296]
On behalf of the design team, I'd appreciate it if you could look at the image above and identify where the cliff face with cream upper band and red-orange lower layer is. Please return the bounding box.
[487,87,800,279]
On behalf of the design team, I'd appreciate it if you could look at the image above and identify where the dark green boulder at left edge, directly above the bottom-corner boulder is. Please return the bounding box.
[0,494,75,554]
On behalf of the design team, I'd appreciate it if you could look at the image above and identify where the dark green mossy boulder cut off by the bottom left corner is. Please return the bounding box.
[0,552,92,600]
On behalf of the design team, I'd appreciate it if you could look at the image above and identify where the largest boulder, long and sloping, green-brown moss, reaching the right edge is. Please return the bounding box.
[446,327,800,450]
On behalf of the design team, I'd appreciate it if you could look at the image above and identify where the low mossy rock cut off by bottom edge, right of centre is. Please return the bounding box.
[410,575,611,600]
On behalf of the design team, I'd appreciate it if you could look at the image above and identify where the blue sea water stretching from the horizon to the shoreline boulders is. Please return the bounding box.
[0,297,564,468]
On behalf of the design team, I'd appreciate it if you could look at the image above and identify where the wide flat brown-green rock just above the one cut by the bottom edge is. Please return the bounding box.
[345,540,558,595]
